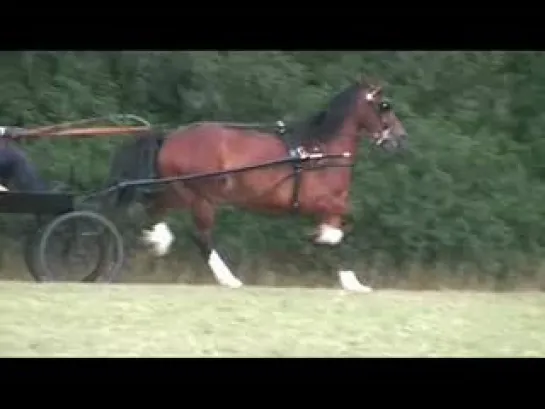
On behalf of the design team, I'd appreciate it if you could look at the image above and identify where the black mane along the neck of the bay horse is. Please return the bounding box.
[287,83,363,144]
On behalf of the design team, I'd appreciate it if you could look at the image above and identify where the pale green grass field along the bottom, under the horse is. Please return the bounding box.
[0,282,545,357]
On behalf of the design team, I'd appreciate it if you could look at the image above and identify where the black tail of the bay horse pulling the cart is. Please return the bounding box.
[107,131,165,206]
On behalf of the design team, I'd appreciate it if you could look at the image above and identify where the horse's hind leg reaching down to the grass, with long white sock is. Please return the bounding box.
[192,199,242,288]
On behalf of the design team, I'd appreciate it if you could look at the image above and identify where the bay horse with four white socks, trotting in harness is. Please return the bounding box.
[111,81,407,292]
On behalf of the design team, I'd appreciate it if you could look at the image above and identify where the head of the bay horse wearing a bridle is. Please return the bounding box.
[357,80,408,151]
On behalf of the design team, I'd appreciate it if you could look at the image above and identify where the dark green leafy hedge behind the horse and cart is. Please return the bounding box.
[0,51,545,286]
